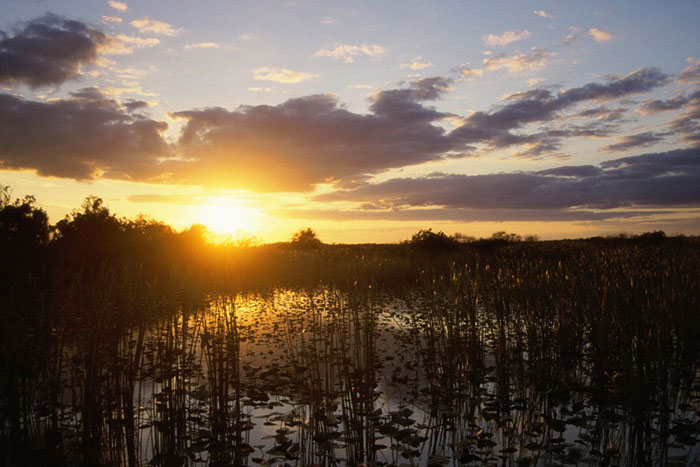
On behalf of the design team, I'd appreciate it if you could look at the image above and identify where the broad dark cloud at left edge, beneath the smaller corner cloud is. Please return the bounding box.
[0,88,169,180]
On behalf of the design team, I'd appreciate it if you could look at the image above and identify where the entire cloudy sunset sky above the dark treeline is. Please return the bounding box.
[0,0,700,243]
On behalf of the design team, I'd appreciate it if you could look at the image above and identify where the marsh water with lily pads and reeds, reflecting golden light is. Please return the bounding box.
[10,276,700,466]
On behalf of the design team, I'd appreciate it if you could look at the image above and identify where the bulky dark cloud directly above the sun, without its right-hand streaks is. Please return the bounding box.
[172,78,461,191]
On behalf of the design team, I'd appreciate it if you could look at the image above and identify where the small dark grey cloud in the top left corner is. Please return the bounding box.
[0,15,108,88]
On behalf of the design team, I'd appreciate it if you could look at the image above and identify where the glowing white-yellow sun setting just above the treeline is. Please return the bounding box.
[197,197,262,241]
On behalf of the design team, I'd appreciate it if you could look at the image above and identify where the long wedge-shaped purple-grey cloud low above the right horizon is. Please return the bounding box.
[316,149,700,209]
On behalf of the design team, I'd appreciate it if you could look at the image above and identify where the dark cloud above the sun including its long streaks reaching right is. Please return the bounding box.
[168,68,668,191]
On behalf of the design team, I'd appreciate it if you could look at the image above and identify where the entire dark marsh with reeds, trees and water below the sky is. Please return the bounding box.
[0,192,700,466]
